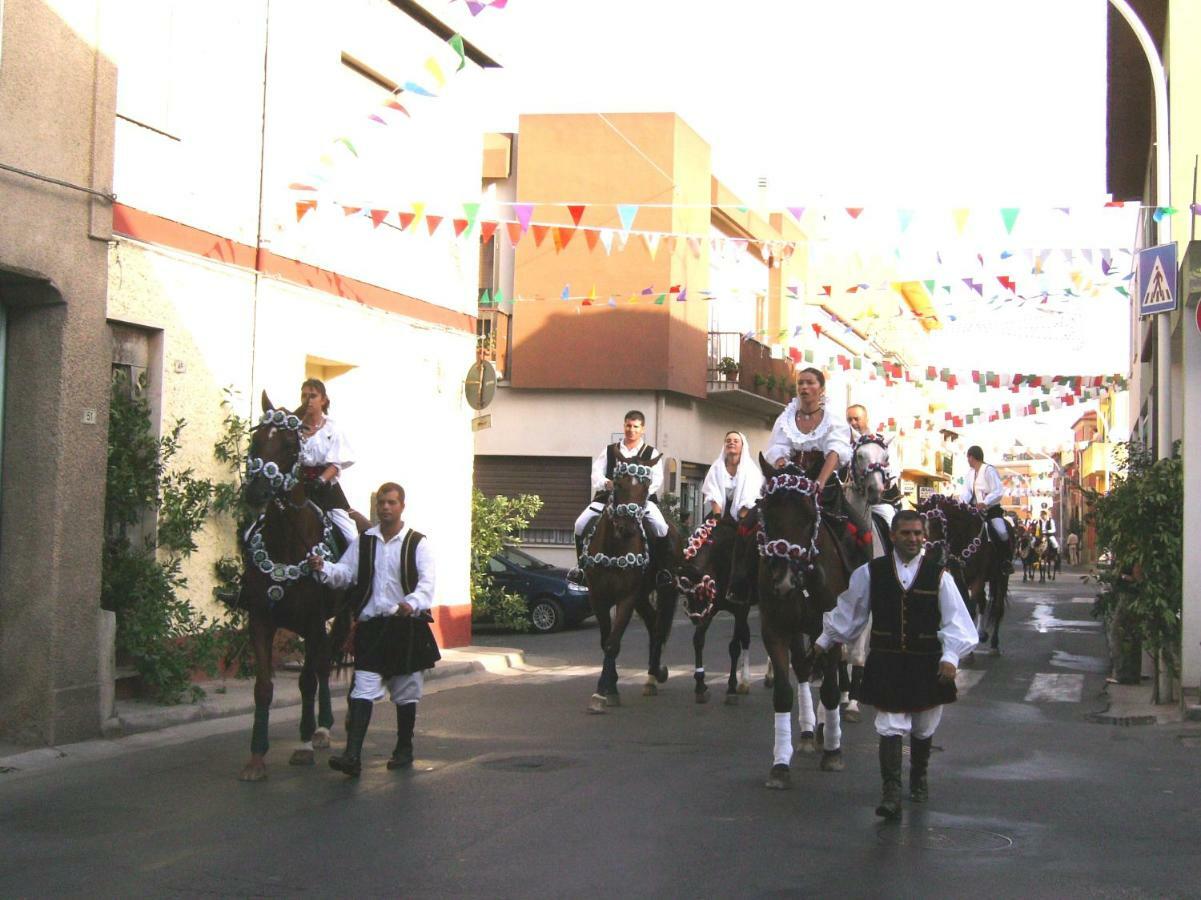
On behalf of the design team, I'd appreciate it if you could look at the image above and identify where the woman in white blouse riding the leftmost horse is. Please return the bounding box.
[297,379,359,544]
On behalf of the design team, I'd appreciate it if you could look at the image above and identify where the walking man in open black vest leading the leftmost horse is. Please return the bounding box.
[309,482,441,777]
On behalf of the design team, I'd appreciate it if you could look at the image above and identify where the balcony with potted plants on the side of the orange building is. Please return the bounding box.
[705,332,795,417]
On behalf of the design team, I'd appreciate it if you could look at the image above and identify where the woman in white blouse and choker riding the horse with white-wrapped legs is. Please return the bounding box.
[763,368,850,490]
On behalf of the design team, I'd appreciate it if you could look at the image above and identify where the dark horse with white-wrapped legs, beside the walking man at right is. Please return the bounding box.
[757,454,850,789]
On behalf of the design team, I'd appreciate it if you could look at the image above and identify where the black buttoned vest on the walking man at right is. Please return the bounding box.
[868,554,943,657]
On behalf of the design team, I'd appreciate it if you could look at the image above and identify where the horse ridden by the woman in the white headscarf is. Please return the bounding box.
[676,517,758,705]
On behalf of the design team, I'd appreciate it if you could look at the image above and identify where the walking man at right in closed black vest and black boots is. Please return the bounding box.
[817,509,979,818]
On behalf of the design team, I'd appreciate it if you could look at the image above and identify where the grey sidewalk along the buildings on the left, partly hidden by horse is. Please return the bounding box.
[0,646,526,775]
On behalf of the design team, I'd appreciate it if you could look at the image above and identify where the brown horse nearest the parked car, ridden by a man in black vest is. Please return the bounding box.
[580,455,681,713]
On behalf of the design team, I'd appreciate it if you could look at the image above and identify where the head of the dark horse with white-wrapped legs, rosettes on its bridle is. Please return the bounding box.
[758,454,821,596]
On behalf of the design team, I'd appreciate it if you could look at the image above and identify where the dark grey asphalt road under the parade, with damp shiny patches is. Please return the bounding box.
[0,578,1201,898]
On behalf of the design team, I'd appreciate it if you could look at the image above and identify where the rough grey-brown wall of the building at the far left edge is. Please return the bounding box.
[0,0,115,744]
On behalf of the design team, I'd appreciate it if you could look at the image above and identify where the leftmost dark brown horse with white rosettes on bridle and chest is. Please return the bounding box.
[231,391,352,781]
